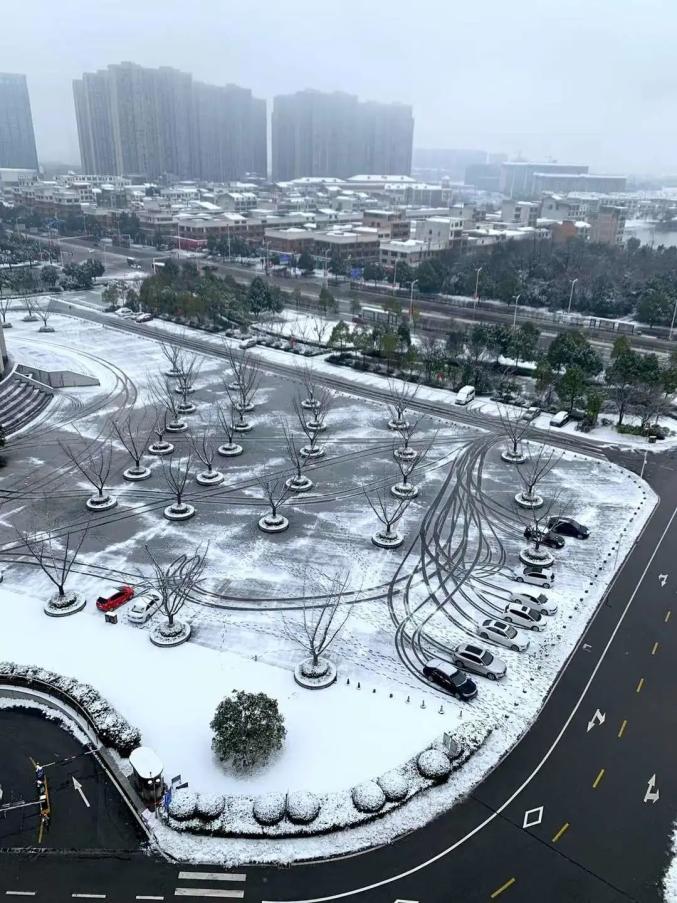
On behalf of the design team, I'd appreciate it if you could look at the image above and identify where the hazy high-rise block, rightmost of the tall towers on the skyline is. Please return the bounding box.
[271,90,414,181]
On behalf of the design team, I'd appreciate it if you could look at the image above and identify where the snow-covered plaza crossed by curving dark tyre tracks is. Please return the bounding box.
[0,314,655,863]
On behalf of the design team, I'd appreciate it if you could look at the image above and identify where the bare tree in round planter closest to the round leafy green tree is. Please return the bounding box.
[283,571,353,681]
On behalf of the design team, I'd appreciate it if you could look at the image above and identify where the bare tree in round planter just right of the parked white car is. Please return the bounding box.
[146,546,209,645]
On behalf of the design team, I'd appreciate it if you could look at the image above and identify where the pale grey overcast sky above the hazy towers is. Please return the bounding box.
[0,0,677,173]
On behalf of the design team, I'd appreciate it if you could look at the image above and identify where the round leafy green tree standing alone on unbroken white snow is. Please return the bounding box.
[210,690,287,769]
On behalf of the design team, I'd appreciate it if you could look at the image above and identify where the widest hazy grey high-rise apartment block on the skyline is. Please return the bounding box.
[73,63,267,181]
